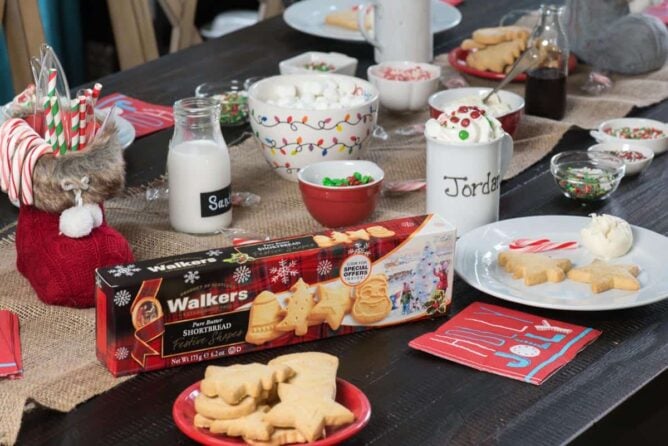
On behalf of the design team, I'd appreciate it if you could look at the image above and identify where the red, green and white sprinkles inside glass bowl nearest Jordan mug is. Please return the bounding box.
[557,167,615,201]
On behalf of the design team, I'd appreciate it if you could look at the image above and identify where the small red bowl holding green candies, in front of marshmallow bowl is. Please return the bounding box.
[298,160,384,228]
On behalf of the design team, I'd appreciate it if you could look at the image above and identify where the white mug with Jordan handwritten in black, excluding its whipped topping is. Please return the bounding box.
[425,133,513,236]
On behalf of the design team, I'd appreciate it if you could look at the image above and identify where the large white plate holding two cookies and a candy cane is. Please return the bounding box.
[455,215,668,311]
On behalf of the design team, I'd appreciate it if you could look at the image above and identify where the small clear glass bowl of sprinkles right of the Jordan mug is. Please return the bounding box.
[550,151,626,202]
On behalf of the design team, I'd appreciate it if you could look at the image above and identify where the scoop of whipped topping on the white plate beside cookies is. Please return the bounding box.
[580,214,633,259]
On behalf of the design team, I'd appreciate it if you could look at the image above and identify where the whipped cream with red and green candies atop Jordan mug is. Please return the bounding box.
[425,105,503,144]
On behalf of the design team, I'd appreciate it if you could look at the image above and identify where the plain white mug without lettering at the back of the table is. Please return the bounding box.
[357,0,434,62]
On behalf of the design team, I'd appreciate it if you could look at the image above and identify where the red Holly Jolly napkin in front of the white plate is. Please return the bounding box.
[409,302,601,385]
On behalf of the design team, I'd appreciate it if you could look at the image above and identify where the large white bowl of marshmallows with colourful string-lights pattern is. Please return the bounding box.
[248,74,378,182]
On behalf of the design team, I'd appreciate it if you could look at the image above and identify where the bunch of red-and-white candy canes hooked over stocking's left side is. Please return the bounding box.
[0,118,53,205]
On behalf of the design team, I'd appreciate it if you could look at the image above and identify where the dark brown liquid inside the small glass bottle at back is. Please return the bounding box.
[524,68,566,120]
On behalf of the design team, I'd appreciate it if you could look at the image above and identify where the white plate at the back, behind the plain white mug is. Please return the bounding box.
[283,0,462,42]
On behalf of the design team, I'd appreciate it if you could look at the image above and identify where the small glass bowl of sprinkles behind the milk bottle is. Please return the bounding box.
[195,80,248,127]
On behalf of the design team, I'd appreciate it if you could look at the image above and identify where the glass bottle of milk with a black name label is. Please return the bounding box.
[167,98,232,234]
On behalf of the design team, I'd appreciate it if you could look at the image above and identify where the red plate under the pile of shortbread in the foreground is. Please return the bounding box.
[172,378,371,446]
